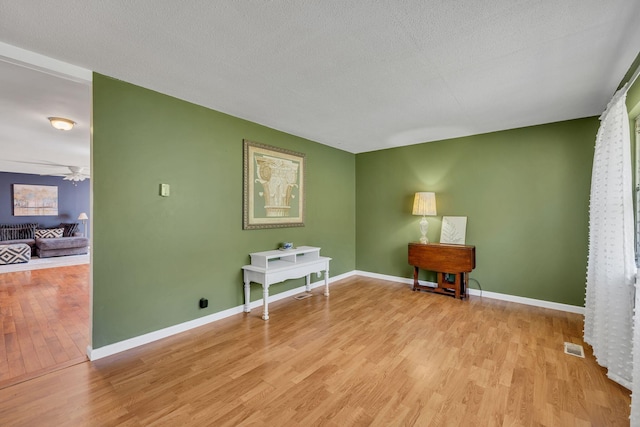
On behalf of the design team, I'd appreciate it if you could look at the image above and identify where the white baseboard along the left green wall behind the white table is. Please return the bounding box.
[87,271,356,360]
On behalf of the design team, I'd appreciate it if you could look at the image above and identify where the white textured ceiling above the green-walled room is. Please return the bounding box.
[0,0,640,167]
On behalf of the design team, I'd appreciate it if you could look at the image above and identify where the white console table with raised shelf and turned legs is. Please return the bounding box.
[242,246,331,320]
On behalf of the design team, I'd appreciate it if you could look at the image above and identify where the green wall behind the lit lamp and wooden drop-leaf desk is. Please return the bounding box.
[356,118,599,306]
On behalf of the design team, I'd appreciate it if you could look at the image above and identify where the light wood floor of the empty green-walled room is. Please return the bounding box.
[0,277,630,426]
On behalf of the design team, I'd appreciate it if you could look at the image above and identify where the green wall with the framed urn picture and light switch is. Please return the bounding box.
[92,74,355,349]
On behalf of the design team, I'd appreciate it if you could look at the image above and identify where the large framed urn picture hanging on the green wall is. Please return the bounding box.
[242,139,305,230]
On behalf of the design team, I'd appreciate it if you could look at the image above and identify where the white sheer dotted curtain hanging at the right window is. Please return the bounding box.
[584,85,636,389]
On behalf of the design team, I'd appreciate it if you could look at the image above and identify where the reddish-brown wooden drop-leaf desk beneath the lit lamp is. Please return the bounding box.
[409,243,476,299]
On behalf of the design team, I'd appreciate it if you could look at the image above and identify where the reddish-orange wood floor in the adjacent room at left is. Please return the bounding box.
[0,264,89,388]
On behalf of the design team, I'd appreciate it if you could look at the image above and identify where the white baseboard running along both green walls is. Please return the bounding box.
[87,270,584,360]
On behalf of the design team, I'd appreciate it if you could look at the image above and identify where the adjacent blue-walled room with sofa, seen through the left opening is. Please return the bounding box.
[0,60,91,387]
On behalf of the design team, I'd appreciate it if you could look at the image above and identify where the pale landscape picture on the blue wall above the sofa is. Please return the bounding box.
[13,184,58,216]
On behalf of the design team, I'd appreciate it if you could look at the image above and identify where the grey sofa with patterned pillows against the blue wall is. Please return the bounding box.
[0,223,89,258]
